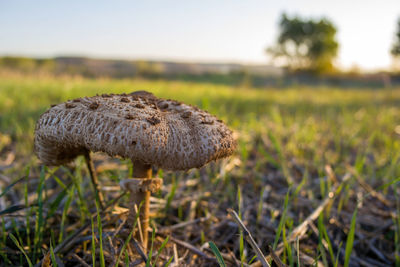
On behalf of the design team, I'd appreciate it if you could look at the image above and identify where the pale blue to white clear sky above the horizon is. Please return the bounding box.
[0,0,400,71]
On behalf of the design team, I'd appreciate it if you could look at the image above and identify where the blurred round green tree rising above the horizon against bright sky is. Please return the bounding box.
[267,14,339,73]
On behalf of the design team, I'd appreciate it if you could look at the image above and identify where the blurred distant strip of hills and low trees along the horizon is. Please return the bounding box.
[0,57,400,88]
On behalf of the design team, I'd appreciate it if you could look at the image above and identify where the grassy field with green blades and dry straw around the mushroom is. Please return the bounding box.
[0,73,400,266]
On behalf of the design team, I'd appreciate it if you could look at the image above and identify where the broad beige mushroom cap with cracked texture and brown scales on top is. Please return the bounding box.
[34,91,236,170]
